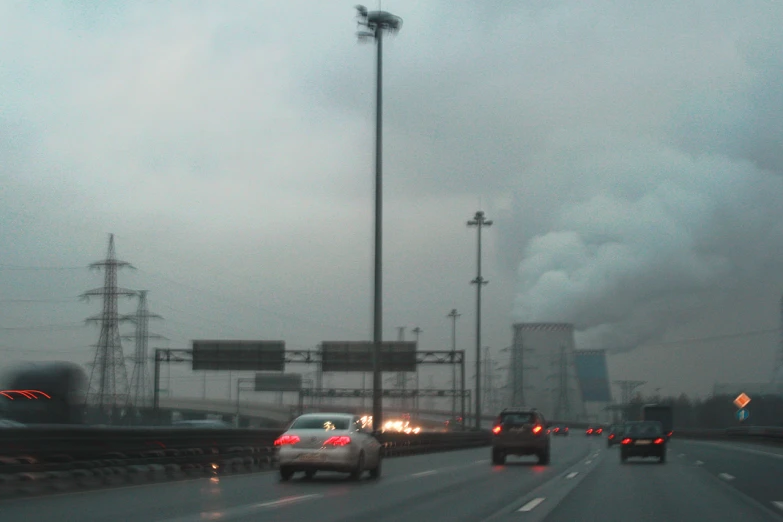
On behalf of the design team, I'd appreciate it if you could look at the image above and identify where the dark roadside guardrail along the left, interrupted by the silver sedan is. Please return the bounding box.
[0,426,490,496]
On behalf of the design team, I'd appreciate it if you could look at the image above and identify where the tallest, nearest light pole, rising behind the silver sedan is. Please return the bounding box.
[356,5,402,433]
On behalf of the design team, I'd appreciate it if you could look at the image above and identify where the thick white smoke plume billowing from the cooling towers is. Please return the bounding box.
[515,137,783,351]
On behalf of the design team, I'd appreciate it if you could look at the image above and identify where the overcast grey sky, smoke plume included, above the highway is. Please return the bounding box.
[0,0,783,400]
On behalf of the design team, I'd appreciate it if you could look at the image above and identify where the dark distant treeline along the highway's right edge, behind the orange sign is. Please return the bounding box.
[626,394,783,431]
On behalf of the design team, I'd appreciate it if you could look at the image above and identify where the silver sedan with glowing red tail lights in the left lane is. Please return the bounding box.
[275,413,381,480]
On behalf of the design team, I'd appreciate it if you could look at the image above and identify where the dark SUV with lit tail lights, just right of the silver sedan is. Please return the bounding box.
[492,408,549,465]
